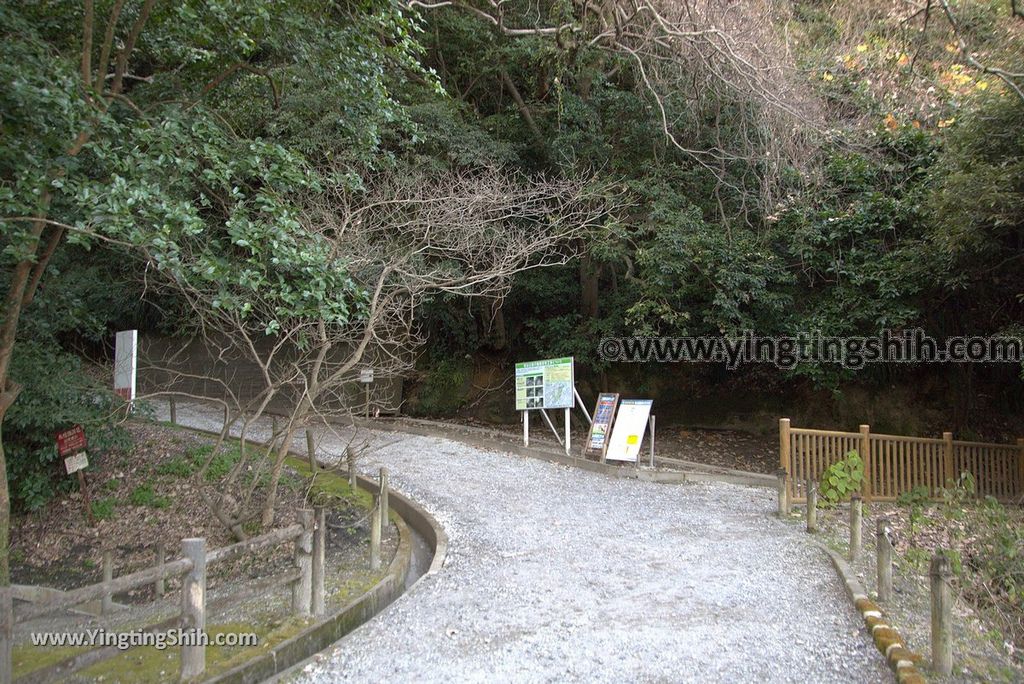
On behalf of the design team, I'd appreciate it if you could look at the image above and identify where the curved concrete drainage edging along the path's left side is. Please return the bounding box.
[167,425,449,684]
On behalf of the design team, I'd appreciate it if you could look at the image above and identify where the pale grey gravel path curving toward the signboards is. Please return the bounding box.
[161,409,892,682]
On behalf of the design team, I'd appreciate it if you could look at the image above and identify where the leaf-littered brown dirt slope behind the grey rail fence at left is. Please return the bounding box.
[11,422,380,603]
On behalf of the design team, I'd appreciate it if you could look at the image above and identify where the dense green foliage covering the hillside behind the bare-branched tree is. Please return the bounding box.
[0,0,1024,506]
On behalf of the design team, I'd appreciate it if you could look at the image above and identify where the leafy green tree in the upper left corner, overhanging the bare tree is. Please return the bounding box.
[0,0,425,660]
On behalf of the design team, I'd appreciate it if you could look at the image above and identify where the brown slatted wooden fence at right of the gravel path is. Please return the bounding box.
[778,418,1024,503]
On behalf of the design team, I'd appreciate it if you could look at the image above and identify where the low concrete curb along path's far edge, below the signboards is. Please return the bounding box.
[355,418,778,487]
